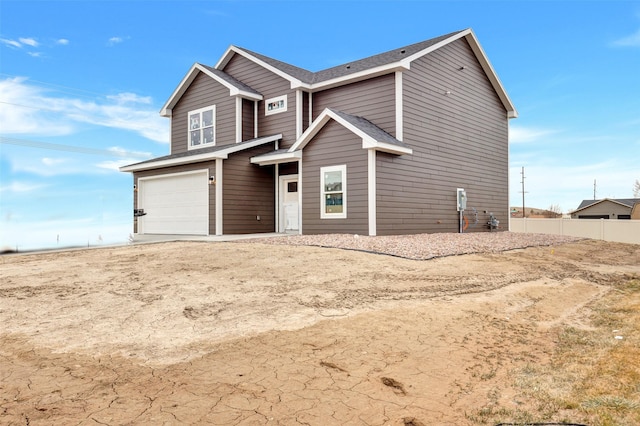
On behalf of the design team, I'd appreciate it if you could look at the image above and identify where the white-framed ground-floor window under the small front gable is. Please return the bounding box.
[320,165,347,219]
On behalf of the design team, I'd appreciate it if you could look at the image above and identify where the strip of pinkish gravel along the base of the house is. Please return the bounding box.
[249,232,582,260]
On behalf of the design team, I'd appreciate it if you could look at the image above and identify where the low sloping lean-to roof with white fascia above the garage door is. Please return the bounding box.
[120,134,282,172]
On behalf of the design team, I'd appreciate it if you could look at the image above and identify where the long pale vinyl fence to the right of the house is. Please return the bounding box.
[509,217,640,244]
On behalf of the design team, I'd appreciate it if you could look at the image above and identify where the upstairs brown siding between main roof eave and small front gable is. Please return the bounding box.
[312,73,396,136]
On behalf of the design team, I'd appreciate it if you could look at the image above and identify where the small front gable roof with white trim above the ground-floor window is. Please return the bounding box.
[289,108,413,155]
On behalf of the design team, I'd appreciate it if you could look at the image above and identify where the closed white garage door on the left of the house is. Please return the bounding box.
[138,170,209,235]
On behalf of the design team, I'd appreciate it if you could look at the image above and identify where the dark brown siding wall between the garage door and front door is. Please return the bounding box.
[222,144,275,234]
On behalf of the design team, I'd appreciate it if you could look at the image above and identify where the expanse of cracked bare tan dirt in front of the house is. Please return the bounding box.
[0,241,640,425]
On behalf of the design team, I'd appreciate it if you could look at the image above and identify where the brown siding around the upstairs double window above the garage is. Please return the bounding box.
[171,73,236,154]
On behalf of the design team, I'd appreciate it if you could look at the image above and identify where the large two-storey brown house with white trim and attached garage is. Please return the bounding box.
[120,29,517,235]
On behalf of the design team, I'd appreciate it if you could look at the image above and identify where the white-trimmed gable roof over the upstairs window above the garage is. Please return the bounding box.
[160,62,263,117]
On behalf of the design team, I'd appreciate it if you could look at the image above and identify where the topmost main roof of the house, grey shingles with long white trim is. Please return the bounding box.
[215,28,518,118]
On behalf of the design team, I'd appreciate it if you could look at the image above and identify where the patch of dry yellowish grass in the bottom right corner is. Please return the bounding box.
[467,276,640,426]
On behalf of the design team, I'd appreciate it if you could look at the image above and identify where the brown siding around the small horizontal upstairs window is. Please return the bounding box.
[224,55,296,148]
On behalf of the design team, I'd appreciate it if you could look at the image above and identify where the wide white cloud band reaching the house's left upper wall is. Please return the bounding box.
[0,77,169,143]
